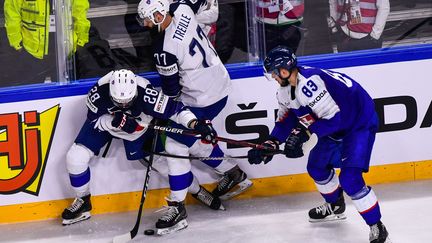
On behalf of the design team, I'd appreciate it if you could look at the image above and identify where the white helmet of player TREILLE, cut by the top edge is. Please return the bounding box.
[138,0,170,25]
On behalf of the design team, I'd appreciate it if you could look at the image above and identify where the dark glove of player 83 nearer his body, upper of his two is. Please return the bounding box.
[284,127,309,158]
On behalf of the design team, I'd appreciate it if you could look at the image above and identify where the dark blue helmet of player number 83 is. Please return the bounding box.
[264,46,297,75]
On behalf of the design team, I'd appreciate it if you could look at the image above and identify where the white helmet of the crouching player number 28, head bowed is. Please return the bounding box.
[109,69,138,108]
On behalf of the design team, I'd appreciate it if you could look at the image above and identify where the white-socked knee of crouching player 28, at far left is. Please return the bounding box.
[66,143,94,175]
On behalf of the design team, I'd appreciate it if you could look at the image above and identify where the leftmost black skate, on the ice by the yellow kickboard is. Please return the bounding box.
[62,195,92,225]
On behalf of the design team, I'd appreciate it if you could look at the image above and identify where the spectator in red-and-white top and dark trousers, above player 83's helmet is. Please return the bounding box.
[257,0,304,52]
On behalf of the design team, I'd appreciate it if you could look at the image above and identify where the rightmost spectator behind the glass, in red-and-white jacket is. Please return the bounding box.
[327,0,390,52]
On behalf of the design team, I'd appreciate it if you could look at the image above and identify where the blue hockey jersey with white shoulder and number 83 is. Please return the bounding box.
[271,66,375,142]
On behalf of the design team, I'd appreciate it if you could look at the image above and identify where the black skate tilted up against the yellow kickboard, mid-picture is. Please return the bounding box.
[212,165,252,200]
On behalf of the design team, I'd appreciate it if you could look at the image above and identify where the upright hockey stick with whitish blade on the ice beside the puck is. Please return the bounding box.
[113,133,158,243]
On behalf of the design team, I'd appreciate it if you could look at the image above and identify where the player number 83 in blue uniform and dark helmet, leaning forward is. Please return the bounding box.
[248,46,390,243]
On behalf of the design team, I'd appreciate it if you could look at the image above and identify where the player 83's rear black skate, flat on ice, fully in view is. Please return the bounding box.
[309,194,346,223]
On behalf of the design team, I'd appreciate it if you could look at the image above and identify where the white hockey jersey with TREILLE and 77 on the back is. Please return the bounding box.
[153,0,231,107]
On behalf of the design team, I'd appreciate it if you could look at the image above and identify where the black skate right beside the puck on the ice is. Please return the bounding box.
[156,199,188,235]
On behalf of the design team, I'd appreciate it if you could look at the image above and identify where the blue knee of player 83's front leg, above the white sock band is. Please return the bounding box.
[339,167,366,197]
